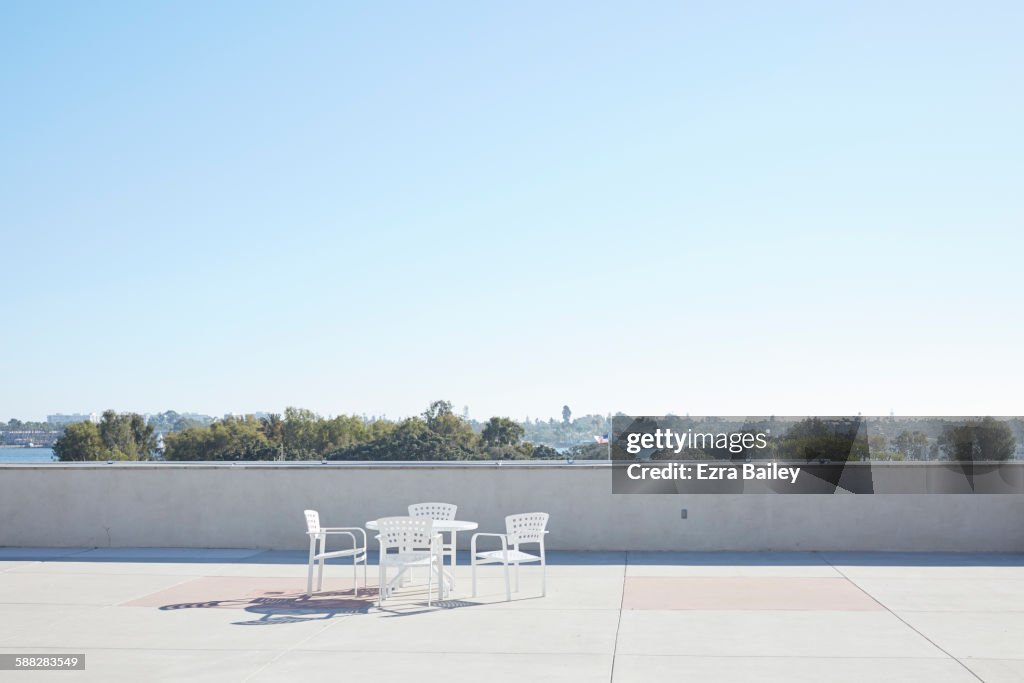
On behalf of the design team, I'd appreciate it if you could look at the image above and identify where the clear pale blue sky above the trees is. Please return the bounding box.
[0,0,1024,420]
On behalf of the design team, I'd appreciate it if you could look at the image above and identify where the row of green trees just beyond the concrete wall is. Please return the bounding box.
[53,411,1017,462]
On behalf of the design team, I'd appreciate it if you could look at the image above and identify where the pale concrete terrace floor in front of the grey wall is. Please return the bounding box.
[0,548,1024,683]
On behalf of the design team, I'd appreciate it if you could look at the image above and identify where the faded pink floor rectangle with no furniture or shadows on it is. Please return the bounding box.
[623,577,884,611]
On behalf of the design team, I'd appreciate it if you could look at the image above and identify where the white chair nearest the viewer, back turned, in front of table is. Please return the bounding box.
[377,517,444,607]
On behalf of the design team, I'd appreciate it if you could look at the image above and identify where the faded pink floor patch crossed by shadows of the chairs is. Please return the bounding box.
[122,577,377,610]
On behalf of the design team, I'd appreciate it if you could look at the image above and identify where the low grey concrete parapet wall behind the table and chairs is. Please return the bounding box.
[0,463,1024,551]
